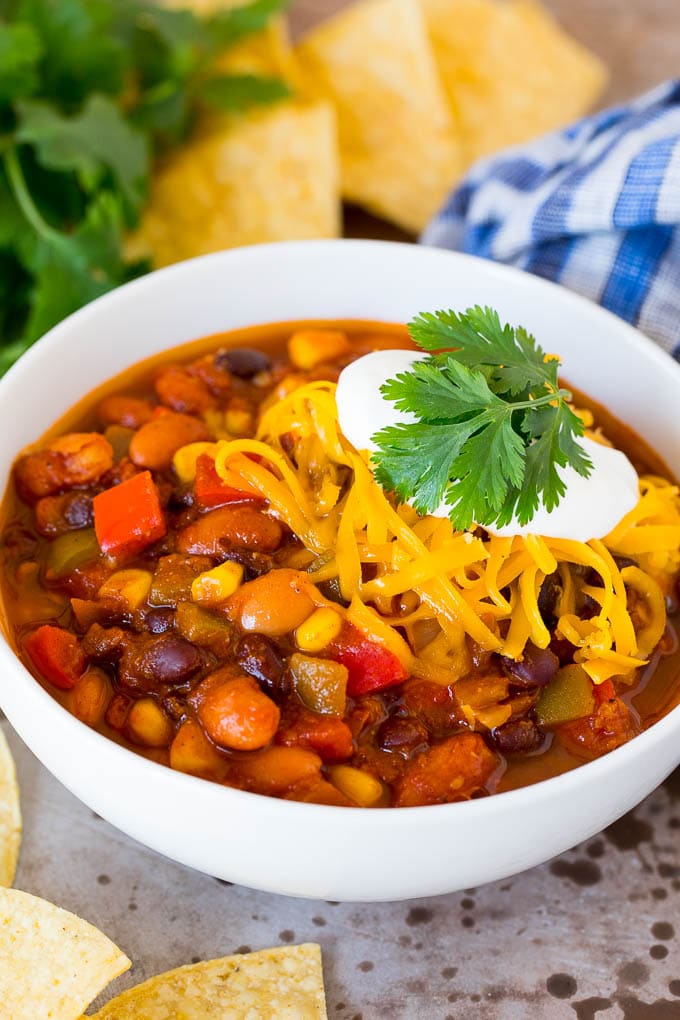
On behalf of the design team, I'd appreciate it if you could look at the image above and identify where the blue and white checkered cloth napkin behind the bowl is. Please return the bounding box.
[421,80,680,360]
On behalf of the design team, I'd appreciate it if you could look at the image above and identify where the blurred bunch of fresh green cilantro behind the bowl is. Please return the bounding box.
[0,0,287,374]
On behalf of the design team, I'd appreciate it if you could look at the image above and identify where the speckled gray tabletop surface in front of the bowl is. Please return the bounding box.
[5,723,680,1020]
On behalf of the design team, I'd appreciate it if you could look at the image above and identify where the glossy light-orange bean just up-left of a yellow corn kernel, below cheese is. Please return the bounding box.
[223,567,316,638]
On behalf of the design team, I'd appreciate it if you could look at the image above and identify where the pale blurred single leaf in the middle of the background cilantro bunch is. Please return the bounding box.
[15,95,149,209]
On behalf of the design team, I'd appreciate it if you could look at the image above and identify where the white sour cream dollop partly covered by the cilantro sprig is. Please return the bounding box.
[335,350,639,542]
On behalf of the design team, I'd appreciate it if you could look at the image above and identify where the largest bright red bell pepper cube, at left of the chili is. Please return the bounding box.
[92,471,167,559]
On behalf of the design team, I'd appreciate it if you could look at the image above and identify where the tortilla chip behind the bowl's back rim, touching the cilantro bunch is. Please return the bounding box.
[126,102,339,266]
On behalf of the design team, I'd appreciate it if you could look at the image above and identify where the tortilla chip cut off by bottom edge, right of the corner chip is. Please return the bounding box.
[95,944,326,1020]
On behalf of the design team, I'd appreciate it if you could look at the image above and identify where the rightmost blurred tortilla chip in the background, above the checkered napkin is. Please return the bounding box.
[420,0,607,164]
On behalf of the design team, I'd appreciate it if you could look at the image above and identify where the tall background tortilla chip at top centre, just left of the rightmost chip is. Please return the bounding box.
[296,0,461,232]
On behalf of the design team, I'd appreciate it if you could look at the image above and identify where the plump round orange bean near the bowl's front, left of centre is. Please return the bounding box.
[199,676,280,751]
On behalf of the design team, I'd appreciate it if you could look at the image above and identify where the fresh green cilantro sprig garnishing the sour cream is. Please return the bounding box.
[372,306,592,528]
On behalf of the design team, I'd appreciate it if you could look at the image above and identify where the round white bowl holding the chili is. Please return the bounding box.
[0,241,680,901]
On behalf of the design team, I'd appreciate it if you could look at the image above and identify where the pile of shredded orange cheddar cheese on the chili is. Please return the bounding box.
[208,381,680,697]
